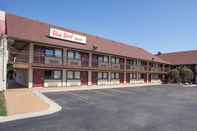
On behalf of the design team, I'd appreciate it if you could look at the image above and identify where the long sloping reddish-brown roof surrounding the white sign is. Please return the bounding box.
[6,14,169,64]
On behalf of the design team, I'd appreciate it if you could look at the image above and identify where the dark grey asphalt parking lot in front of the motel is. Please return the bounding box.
[0,85,197,131]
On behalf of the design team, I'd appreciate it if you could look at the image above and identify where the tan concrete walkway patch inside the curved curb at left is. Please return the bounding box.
[5,89,49,116]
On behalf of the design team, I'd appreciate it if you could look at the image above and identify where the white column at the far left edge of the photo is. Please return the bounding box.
[0,36,8,90]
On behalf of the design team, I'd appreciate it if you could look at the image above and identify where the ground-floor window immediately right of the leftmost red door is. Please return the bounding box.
[44,70,62,80]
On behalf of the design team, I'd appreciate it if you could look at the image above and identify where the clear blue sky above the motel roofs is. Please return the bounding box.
[0,0,197,53]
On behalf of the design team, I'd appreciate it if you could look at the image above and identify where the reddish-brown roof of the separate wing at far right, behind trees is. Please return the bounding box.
[158,50,197,65]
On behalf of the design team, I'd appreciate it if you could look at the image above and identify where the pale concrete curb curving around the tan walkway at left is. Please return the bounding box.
[0,91,62,123]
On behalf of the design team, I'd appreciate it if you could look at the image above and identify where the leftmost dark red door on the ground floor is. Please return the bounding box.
[33,69,44,87]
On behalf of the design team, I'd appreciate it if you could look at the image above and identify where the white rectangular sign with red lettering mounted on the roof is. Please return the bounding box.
[49,28,86,44]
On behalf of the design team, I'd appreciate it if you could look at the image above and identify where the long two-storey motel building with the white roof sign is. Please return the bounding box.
[0,11,170,90]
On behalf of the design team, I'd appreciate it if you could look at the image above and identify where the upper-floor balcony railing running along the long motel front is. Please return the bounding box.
[8,51,170,72]
